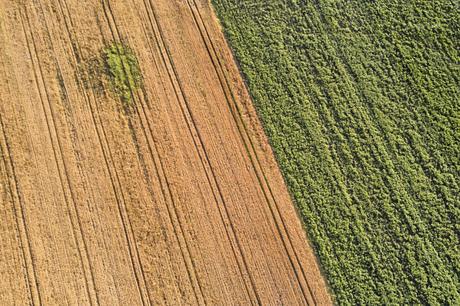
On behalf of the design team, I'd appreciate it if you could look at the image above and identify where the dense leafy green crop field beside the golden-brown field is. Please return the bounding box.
[213,0,460,305]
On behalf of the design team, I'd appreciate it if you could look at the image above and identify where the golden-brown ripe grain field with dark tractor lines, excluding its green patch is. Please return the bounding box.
[0,0,331,305]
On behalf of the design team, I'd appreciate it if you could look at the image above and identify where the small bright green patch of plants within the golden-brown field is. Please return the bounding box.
[102,43,142,104]
